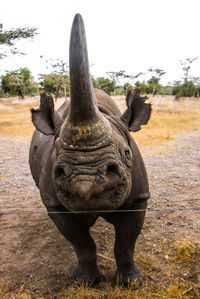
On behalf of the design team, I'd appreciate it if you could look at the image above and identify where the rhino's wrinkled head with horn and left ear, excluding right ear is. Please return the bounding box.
[32,15,150,211]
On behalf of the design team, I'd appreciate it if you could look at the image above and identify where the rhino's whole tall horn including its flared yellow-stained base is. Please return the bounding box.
[61,14,110,146]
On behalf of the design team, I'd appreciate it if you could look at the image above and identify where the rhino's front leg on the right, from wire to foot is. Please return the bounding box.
[104,200,147,286]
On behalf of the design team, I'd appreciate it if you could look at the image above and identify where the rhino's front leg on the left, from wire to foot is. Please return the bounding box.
[48,209,101,285]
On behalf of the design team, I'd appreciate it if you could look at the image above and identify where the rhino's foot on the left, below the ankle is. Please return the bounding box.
[71,266,102,286]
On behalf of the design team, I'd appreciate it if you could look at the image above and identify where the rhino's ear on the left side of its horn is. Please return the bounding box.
[31,92,62,135]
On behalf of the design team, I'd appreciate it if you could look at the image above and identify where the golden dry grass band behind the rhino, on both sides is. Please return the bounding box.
[0,97,200,146]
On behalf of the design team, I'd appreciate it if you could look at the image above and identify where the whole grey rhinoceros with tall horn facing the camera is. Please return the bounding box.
[29,14,151,285]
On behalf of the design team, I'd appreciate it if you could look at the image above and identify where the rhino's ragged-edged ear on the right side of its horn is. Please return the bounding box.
[121,88,151,132]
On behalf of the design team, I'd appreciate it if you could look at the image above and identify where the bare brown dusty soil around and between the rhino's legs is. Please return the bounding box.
[0,131,200,292]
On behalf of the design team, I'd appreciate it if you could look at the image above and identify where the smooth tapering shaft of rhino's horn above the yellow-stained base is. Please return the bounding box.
[69,14,98,125]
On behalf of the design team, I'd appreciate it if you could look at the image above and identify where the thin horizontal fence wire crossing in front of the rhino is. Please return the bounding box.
[0,207,200,215]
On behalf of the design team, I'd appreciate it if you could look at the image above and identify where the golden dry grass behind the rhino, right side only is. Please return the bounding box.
[116,96,200,147]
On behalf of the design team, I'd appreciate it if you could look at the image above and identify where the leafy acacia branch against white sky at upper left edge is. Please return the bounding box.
[0,24,37,59]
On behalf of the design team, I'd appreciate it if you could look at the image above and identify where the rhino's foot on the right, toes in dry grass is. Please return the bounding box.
[114,265,142,289]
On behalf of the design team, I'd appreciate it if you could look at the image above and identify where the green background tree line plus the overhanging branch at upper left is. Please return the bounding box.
[0,24,200,99]
